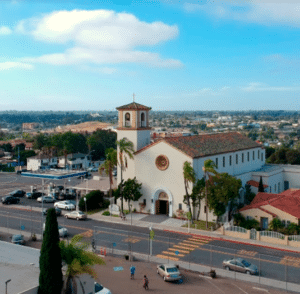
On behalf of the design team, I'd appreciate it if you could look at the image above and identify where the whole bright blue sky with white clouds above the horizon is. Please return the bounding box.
[0,0,300,110]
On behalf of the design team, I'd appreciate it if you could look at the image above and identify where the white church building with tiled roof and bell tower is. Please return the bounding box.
[117,102,296,221]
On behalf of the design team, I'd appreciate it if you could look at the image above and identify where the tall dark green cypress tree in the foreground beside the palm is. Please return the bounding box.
[38,208,63,294]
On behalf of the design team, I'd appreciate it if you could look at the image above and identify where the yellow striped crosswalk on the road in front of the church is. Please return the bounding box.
[156,236,214,261]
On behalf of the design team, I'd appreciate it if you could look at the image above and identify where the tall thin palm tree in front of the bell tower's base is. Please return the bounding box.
[117,138,134,213]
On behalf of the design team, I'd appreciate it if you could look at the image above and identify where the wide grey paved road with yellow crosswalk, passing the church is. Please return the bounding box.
[0,206,300,283]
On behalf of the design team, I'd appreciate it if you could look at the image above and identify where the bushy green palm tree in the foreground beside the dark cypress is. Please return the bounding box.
[59,235,105,294]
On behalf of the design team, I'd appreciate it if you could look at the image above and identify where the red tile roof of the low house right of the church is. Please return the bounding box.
[240,190,300,219]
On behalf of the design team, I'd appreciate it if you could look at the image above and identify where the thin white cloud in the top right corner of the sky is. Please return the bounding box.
[183,0,300,27]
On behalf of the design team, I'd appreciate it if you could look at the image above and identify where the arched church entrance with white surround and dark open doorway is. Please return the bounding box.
[151,187,173,216]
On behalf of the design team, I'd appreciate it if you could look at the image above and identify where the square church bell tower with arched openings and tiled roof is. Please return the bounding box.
[117,102,151,151]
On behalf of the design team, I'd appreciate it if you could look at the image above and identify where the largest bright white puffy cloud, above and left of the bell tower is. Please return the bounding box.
[16,10,182,67]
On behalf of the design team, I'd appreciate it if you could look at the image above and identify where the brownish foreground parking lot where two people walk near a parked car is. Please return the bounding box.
[96,256,292,294]
